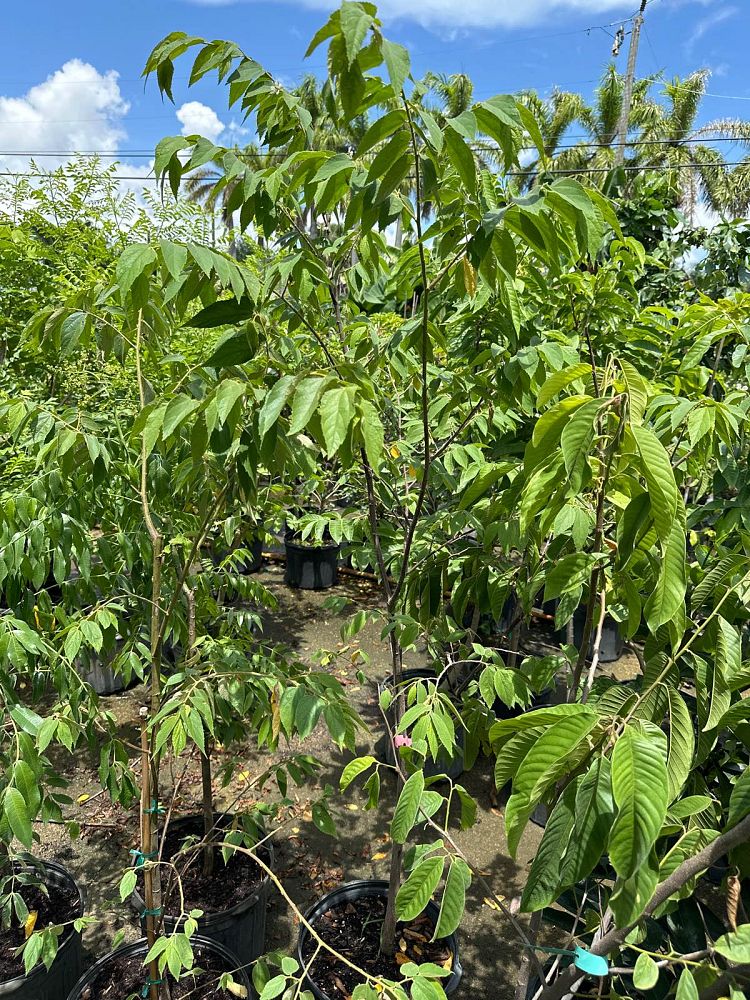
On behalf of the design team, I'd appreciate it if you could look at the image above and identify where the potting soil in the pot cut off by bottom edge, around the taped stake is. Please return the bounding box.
[78,950,241,1000]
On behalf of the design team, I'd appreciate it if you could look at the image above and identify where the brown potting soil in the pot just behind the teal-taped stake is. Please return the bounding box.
[144,817,267,916]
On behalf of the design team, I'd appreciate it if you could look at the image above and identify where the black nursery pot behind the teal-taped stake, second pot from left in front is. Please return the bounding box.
[130,815,273,965]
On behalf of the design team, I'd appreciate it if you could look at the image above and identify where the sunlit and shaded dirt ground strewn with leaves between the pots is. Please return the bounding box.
[39,563,633,1000]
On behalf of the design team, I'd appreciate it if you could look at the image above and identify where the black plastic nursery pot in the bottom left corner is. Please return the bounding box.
[0,861,85,1000]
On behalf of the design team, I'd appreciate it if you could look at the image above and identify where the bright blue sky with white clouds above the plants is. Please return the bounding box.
[0,0,750,180]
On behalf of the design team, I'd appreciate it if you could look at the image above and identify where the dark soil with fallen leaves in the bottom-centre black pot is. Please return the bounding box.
[303,896,453,1000]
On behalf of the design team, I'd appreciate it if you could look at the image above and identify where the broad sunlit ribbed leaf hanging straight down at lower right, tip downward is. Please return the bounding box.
[609,726,668,879]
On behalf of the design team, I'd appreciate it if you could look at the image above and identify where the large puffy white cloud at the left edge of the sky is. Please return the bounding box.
[0,59,129,170]
